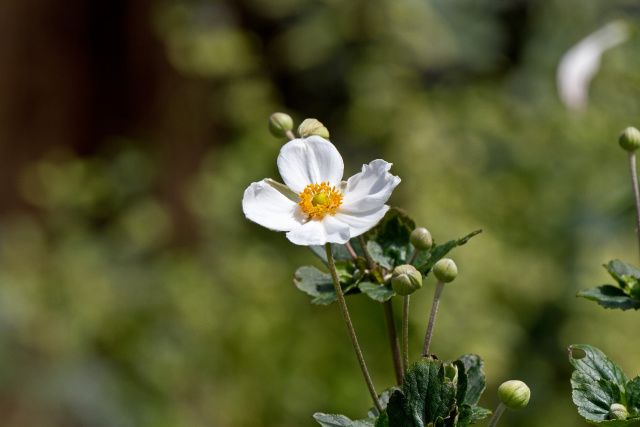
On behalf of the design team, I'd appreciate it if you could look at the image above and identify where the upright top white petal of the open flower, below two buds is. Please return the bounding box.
[278,136,344,193]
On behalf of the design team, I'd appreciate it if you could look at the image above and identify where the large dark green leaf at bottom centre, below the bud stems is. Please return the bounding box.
[387,358,457,427]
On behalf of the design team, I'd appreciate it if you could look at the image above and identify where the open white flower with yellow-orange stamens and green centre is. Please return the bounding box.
[242,136,400,246]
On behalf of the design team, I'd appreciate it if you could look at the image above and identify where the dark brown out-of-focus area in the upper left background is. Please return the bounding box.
[0,0,208,243]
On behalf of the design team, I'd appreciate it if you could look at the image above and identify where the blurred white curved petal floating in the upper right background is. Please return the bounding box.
[556,21,629,110]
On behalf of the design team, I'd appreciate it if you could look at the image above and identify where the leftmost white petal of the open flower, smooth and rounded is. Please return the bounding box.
[242,179,305,231]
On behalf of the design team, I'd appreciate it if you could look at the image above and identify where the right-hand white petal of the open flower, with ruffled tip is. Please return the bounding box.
[338,159,400,213]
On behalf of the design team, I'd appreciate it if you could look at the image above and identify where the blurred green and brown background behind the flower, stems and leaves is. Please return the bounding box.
[0,0,640,427]
